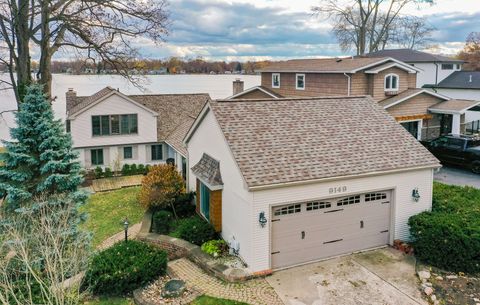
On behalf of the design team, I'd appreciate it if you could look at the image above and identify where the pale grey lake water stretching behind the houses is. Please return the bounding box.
[0,74,260,141]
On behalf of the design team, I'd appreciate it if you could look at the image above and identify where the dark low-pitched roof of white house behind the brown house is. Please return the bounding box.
[365,49,463,63]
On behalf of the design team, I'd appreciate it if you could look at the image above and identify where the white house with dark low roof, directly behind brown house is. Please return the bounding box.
[365,49,465,87]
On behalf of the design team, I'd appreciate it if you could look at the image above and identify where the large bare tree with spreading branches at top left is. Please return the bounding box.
[0,0,168,102]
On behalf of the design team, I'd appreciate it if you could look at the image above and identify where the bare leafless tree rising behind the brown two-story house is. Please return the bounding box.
[312,0,433,55]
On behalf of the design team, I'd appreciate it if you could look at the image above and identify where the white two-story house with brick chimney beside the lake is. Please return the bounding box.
[66,87,210,175]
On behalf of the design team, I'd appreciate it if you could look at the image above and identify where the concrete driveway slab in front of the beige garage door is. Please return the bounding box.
[267,248,427,305]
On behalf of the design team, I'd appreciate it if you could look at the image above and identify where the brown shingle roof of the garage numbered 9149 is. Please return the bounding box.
[210,97,439,187]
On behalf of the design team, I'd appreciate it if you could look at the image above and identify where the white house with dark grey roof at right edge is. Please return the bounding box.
[424,71,480,122]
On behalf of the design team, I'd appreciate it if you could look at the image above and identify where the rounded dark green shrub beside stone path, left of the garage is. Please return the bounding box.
[84,240,167,295]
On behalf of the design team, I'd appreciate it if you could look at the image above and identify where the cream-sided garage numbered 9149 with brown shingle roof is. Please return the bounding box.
[185,96,440,273]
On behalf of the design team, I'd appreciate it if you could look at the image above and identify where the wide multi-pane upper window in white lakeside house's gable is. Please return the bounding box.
[92,113,138,136]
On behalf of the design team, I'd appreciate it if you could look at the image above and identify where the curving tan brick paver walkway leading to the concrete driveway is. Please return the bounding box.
[168,258,283,305]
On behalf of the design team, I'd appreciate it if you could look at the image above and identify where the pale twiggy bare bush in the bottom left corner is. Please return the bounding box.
[0,196,90,305]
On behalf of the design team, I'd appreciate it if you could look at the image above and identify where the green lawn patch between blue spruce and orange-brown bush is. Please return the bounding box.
[81,187,145,247]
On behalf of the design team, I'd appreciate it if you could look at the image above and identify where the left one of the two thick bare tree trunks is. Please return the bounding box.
[16,0,32,103]
